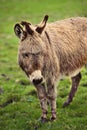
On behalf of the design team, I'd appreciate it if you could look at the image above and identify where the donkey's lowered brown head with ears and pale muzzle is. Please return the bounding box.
[14,15,48,85]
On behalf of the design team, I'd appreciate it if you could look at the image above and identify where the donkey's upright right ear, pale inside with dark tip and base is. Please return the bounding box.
[36,15,48,34]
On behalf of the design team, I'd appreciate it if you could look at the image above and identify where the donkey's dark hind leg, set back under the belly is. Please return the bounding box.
[63,73,81,107]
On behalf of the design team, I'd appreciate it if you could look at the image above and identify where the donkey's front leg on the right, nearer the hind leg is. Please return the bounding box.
[47,85,57,120]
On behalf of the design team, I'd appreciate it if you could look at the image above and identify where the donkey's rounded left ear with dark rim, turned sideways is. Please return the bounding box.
[14,24,26,39]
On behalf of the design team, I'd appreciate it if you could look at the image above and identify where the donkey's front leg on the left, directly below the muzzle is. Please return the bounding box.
[36,85,47,122]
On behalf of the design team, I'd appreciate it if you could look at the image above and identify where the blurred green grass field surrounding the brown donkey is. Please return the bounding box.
[0,0,87,130]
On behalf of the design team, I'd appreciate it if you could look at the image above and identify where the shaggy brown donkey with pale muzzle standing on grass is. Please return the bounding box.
[14,15,87,121]
